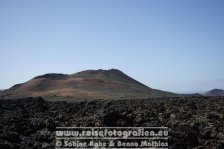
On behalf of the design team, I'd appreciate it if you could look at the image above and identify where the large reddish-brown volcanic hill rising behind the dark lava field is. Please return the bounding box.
[0,69,177,99]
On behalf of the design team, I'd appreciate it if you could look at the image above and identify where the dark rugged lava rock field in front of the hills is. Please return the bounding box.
[0,97,224,149]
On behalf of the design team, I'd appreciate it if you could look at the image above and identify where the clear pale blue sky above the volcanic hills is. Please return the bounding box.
[0,0,224,93]
